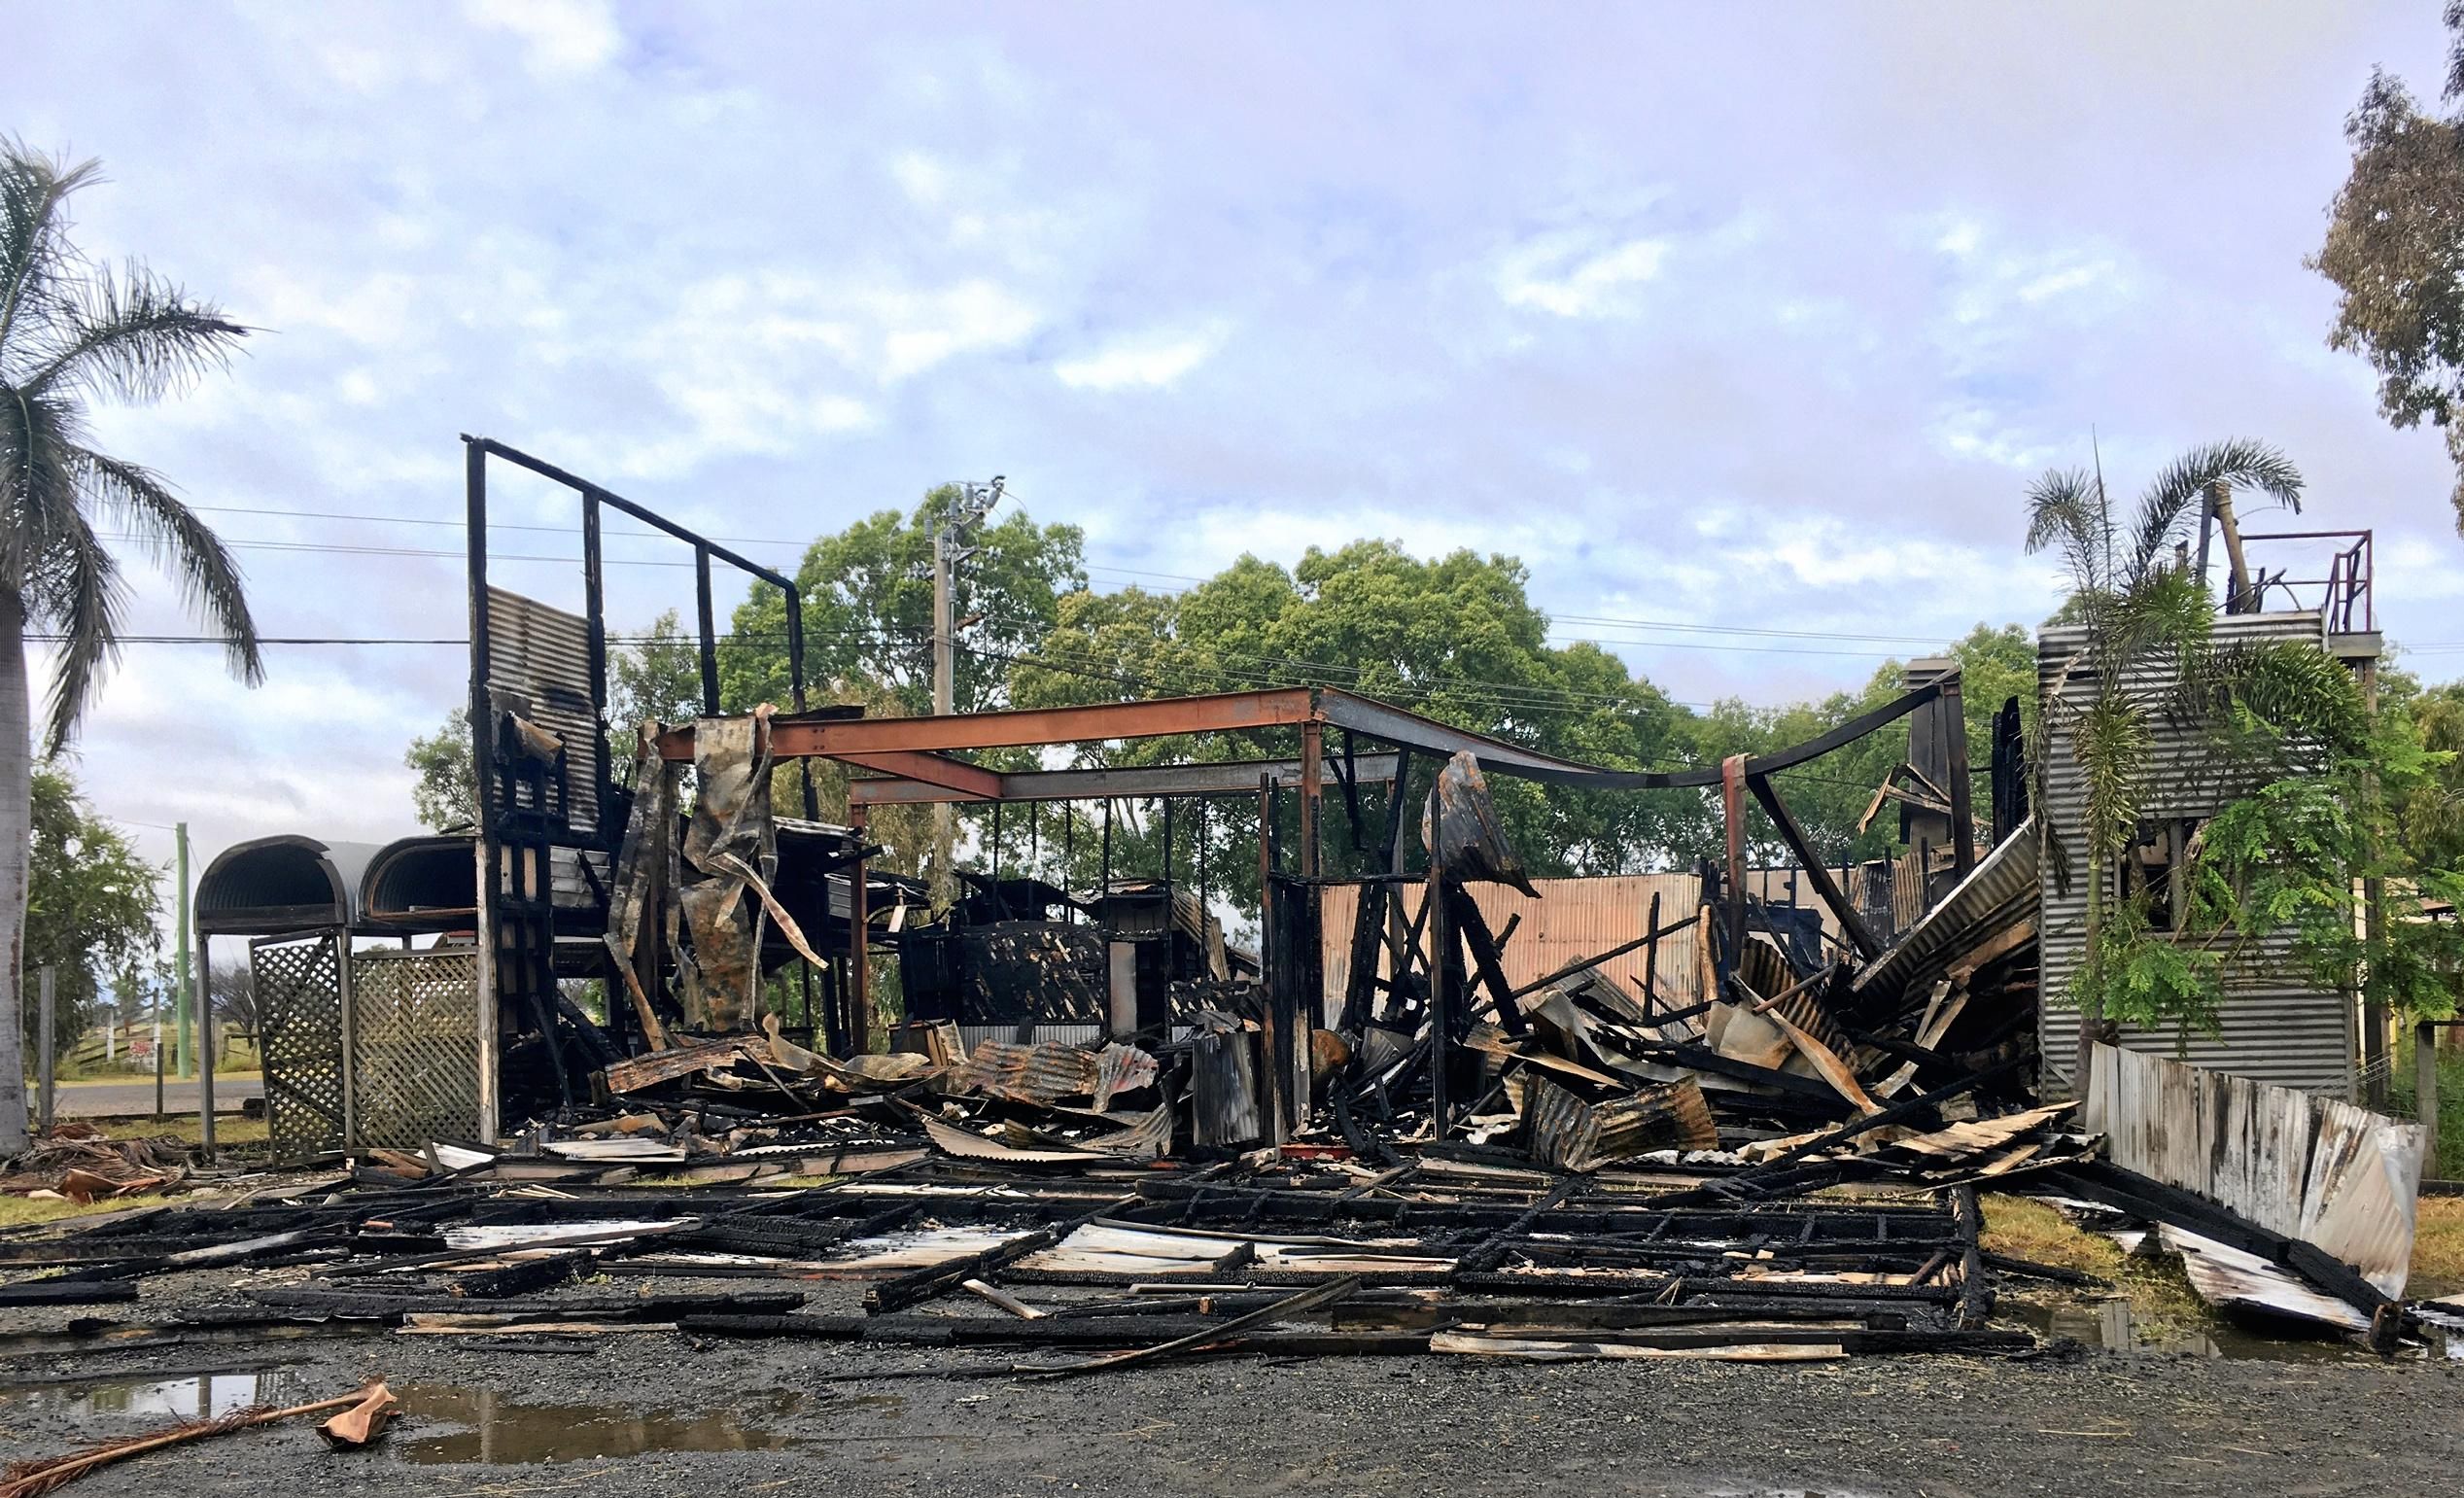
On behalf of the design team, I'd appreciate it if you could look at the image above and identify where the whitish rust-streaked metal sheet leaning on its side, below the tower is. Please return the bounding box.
[2082,1045,2430,1296]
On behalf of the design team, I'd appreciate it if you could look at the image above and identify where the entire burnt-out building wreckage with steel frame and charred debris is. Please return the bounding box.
[23,438,2419,1377]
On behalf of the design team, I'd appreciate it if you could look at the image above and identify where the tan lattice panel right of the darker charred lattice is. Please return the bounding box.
[350,951,478,1151]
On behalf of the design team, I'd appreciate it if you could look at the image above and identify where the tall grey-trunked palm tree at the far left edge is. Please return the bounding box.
[0,138,263,1156]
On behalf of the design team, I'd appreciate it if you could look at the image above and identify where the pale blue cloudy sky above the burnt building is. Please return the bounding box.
[0,0,2464,887]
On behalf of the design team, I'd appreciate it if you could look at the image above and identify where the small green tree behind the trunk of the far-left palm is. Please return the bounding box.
[24,766,162,1055]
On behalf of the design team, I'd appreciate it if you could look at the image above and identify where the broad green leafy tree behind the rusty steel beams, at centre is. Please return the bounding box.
[1010,540,1700,907]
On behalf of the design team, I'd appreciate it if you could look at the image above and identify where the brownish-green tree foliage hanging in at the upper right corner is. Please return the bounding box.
[2308,0,2464,530]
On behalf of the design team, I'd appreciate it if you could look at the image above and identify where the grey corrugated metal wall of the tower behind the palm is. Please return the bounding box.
[2037,613,2353,1094]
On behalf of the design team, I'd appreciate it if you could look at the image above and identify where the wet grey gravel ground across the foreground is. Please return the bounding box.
[0,1273,2464,1498]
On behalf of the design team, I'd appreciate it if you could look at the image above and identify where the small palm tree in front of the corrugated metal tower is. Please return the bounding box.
[2028,441,2358,1089]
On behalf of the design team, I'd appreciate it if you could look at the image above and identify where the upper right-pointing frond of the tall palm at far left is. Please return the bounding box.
[22,261,249,401]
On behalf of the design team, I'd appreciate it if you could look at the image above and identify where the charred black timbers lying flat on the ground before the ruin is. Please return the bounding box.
[0,1132,2065,1373]
